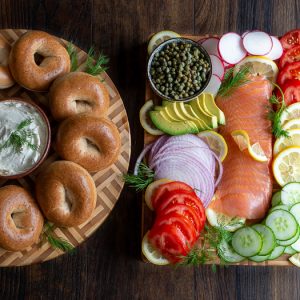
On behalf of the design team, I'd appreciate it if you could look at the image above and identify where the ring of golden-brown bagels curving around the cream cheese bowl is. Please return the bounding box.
[0,31,121,251]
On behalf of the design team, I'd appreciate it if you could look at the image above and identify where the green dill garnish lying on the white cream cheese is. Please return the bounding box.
[0,119,37,152]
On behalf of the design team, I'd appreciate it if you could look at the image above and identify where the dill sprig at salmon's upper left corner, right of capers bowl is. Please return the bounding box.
[218,66,249,97]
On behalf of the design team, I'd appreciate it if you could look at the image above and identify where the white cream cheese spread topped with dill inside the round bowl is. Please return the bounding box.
[0,100,48,176]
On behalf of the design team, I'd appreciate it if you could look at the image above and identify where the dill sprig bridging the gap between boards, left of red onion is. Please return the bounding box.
[123,163,154,192]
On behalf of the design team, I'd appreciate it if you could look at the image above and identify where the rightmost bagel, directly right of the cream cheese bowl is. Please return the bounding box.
[56,114,121,172]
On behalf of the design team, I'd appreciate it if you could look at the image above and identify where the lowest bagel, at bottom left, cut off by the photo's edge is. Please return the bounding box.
[0,185,44,251]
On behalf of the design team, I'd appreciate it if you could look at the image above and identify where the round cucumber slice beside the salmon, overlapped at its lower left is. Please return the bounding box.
[266,209,298,241]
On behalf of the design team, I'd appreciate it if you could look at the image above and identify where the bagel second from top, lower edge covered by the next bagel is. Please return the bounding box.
[49,72,109,121]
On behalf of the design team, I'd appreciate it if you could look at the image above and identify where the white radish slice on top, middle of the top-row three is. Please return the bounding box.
[243,30,273,55]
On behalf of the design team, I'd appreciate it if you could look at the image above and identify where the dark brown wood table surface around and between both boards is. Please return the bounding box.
[0,0,300,300]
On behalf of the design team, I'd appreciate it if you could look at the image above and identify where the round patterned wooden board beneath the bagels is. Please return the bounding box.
[0,29,131,267]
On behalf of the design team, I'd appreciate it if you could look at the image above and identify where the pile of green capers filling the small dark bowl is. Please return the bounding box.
[150,41,210,100]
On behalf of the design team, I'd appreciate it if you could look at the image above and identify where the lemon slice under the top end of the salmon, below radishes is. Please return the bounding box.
[233,56,278,82]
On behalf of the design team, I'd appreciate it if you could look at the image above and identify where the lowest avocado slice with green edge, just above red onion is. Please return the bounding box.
[149,111,199,135]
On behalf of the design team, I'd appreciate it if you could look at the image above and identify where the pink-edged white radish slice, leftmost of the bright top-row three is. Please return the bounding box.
[218,32,247,65]
